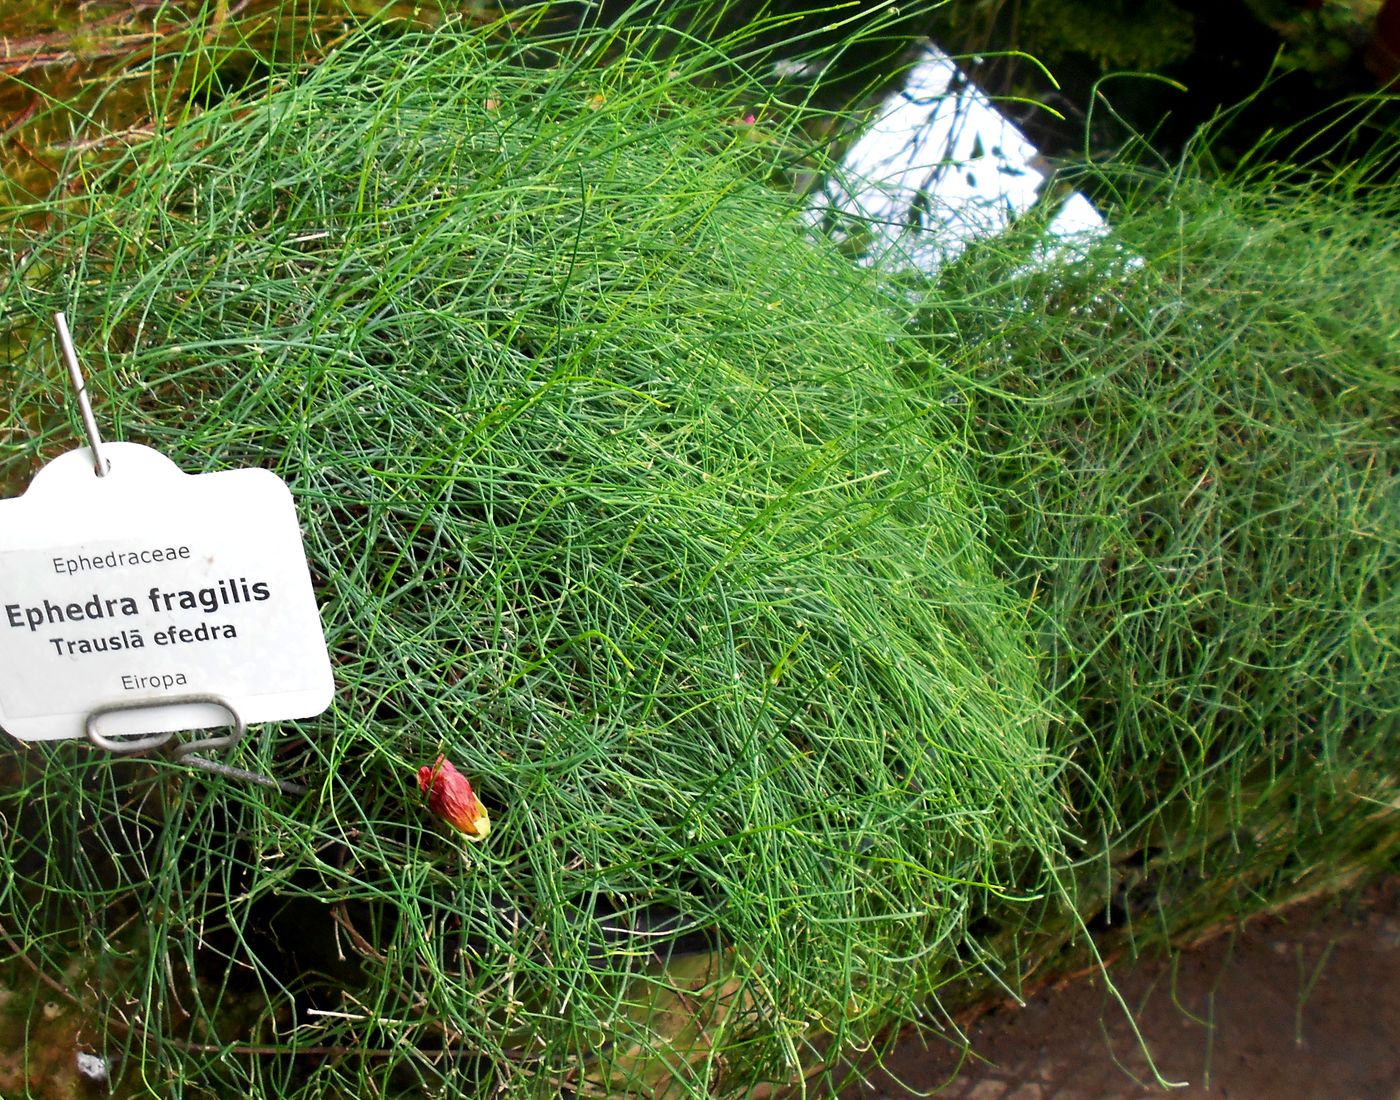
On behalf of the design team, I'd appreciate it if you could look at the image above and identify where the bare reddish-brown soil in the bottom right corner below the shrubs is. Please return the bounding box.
[843,877,1400,1100]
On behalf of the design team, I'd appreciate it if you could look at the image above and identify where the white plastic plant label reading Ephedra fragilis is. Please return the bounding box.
[0,444,333,740]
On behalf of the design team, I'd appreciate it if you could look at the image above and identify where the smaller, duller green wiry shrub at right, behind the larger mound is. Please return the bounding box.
[923,135,1400,935]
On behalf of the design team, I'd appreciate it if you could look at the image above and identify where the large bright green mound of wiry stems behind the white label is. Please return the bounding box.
[0,17,1060,1097]
